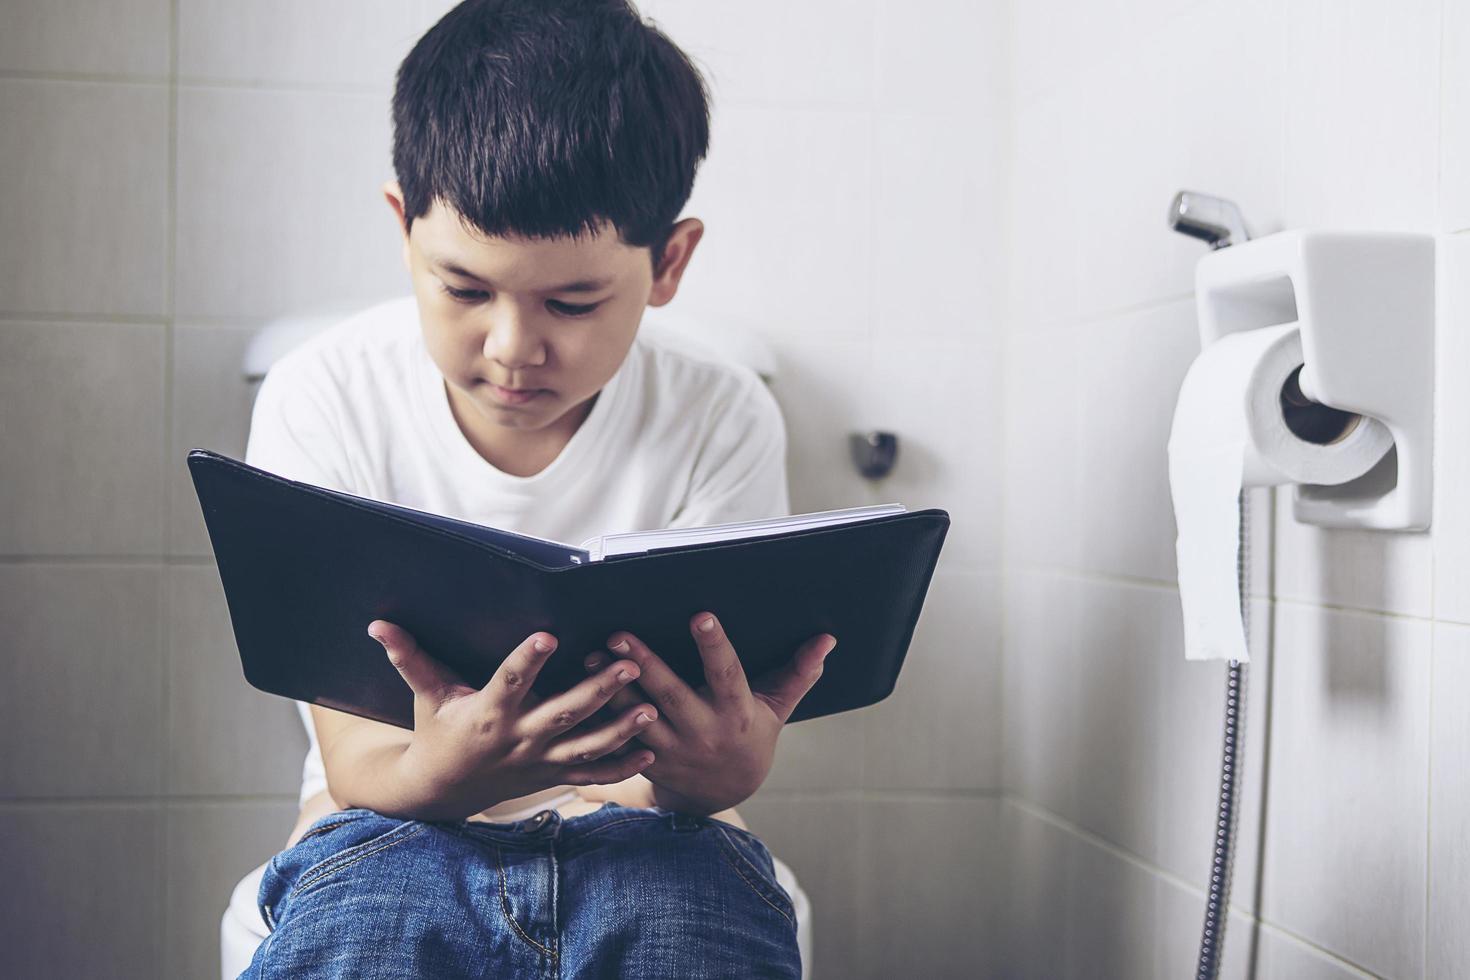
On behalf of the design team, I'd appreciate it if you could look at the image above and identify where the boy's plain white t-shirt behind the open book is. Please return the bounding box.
[245,297,789,802]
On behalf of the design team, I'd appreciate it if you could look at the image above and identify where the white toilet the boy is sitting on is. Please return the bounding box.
[219,309,811,980]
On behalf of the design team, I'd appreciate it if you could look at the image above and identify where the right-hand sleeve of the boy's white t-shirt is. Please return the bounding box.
[669,375,791,527]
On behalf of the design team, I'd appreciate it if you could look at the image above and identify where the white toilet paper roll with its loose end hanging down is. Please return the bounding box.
[1169,323,1394,663]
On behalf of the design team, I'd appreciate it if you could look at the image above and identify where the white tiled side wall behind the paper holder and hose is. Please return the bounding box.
[997,0,1470,979]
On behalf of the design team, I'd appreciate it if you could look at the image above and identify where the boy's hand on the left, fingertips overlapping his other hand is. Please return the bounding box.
[368,620,659,820]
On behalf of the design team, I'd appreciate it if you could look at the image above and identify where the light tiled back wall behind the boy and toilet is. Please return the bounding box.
[0,0,1008,977]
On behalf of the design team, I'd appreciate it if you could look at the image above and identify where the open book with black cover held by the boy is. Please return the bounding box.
[188,450,950,727]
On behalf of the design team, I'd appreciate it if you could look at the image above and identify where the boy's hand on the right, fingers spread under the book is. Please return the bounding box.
[585,613,836,814]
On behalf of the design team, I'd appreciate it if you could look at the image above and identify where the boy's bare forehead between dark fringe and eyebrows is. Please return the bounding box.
[410,203,647,288]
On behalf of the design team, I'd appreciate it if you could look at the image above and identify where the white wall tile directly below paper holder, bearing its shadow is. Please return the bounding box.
[1261,604,1430,976]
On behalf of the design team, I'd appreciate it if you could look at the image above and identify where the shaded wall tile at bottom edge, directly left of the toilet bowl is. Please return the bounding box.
[159,798,297,977]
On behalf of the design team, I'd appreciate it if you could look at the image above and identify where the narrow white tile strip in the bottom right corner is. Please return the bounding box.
[1426,624,1470,980]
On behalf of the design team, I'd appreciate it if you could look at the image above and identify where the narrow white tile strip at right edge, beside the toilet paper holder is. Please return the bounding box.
[1430,235,1470,623]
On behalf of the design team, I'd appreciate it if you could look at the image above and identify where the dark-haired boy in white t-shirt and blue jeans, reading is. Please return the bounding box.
[245,0,836,977]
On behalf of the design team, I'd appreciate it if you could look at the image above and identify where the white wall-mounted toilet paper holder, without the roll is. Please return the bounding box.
[1195,231,1435,530]
